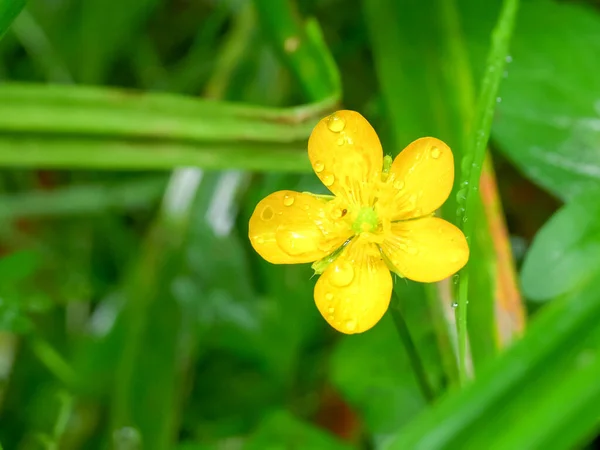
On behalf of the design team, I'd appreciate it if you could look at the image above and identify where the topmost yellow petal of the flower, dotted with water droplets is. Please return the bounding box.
[308,111,383,206]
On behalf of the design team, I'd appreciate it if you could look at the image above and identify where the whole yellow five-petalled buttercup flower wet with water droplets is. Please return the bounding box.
[249,111,469,334]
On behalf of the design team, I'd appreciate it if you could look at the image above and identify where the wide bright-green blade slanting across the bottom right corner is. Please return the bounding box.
[385,280,600,450]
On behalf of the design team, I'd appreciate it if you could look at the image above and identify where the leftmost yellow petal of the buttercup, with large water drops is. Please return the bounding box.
[248,191,352,264]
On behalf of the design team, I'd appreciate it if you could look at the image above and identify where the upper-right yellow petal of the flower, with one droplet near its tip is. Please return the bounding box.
[378,137,454,220]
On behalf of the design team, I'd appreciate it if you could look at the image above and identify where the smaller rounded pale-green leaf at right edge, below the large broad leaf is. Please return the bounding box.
[521,190,600,300]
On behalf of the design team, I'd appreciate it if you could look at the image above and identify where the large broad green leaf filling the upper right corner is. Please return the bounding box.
[494,0,600,199]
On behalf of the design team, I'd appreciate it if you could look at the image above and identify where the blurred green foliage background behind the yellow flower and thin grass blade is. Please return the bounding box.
[0,0,600,450]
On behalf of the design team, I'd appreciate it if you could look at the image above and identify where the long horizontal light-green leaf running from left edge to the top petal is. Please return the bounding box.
[0,84,334,172]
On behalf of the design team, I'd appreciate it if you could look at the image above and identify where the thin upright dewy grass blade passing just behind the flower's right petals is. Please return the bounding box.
[456,0,519,385]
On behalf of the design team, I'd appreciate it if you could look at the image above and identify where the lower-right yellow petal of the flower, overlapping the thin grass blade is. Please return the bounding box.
[382,217,469,283]
